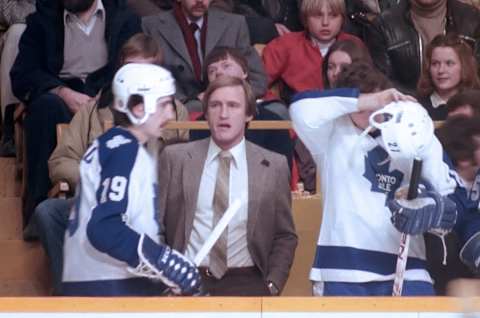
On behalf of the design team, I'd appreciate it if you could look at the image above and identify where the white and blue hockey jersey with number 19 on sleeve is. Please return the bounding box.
[63,127,159,284]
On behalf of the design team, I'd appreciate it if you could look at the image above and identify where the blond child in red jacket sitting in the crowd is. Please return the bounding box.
[263,0,363,102]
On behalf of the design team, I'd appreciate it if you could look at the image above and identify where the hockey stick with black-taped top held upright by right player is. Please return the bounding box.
[392,158,422,296]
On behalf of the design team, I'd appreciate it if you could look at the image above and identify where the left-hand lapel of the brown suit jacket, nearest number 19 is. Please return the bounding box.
[182,138,210,248]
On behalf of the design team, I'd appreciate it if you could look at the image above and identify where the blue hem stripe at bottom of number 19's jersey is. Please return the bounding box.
[61,277,166,297]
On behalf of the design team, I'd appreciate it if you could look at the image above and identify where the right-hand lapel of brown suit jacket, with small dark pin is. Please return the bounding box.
[246,141,270,241]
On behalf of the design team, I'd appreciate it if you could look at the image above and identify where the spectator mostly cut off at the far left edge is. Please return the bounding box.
[0,0,35,157]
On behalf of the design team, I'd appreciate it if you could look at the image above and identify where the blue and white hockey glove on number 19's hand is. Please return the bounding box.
[130,234,201,295]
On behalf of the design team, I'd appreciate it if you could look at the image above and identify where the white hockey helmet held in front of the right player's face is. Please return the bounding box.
[369,101,434,159]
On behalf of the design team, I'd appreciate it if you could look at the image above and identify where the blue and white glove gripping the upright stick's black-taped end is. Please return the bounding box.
[388,182,457,236]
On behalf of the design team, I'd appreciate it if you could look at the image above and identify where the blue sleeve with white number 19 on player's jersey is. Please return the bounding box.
[87,128,140,267]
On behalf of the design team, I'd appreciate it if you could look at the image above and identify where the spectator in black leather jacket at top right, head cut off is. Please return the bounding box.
[366,0,480,94]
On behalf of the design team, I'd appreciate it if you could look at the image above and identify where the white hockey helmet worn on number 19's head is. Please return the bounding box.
[112,63,175,125]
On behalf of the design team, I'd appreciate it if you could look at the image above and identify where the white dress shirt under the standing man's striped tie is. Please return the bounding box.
[186,138,254,268]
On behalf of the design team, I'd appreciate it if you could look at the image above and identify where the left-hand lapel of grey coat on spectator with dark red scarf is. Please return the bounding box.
[158,13,193,70]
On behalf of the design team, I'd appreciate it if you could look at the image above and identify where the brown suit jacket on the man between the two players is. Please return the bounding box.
[159,138,297,290]
